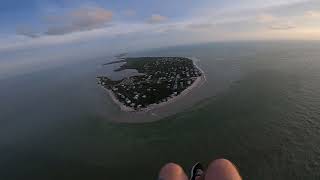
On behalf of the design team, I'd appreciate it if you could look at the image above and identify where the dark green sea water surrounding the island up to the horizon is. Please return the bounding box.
[0,42,320,179]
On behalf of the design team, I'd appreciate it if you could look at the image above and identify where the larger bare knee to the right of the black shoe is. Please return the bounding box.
[206,159,241,180]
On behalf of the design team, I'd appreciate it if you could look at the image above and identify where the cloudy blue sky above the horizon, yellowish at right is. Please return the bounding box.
[0,0,320,79]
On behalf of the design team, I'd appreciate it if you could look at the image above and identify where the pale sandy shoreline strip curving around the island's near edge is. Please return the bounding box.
[102,57,206,113]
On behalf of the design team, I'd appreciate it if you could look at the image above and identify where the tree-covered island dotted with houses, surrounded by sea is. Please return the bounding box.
[97,57,203,111]
